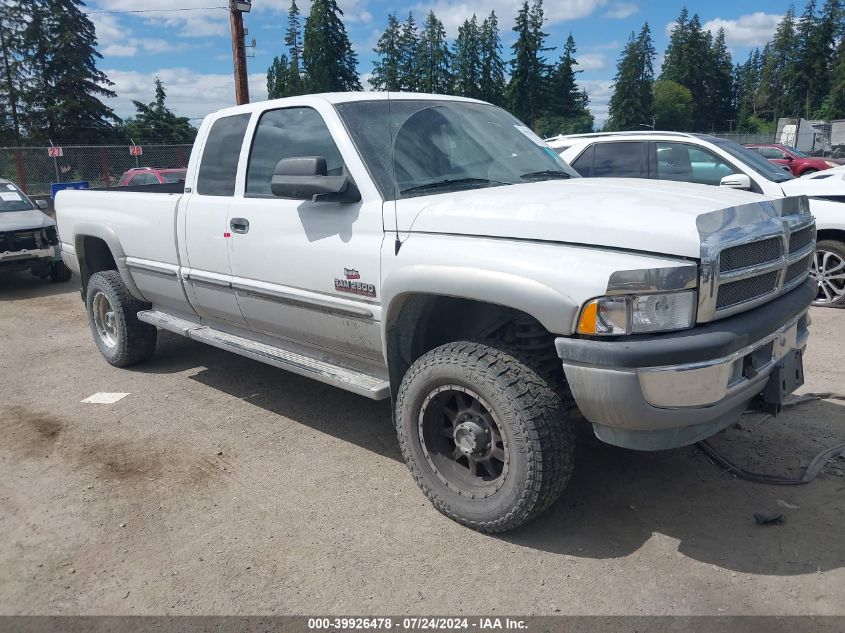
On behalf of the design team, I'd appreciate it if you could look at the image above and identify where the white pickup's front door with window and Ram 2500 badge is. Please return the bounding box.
[227,107,384,360]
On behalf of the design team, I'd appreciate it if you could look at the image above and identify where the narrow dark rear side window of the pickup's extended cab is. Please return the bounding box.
[197,113,250,196]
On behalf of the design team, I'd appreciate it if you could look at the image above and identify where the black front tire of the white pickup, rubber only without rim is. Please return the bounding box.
[395,341,575,533]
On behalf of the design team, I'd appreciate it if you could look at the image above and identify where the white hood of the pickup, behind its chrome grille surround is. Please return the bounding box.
[397,178,767,258]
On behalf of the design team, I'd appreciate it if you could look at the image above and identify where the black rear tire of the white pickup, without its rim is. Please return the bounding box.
[85,270,157,367]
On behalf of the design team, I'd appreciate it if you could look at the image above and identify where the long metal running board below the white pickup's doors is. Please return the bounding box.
[138,310,390,400]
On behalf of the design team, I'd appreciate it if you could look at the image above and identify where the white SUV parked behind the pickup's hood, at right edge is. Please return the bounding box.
[546,131,845,307]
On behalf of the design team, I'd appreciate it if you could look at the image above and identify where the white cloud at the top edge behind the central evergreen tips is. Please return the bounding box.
[411,0,610,37]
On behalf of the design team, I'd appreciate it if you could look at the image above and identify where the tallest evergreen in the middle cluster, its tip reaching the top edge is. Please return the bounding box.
[506,0,548,126]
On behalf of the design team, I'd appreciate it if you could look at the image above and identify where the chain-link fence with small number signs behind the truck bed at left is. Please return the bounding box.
[0,144,191,195]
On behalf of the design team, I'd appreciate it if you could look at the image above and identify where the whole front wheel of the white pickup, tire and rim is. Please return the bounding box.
[396,341,574,532]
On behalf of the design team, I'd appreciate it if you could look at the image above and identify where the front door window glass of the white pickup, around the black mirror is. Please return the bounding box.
[246,108,344,196]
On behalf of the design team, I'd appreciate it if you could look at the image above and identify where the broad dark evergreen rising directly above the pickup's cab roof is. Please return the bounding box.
[302,0,361,92]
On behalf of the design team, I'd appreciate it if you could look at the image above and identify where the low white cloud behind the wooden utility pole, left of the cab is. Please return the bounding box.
[104,68,267,119]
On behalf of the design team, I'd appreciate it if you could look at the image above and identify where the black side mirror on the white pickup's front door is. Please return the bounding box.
[270,156,361,202]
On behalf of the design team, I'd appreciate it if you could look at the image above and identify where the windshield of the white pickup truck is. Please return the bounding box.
[336,99,579,200]
